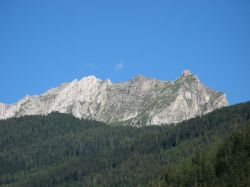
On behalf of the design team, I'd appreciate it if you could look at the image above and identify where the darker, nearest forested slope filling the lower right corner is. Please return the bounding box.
[150,122,250,187]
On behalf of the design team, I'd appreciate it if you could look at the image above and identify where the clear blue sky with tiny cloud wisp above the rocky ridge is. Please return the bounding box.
[0,0,250,104]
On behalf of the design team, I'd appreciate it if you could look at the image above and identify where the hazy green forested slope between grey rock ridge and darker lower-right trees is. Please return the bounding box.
[0,102,250,187]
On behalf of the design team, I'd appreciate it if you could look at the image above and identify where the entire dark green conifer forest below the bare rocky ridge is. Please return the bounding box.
[0,102,250,187]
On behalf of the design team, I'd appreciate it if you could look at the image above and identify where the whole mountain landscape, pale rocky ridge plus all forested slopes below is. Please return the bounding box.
[0,70,250,187]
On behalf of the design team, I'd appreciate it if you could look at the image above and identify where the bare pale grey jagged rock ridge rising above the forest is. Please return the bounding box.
[0,70,228,126]
